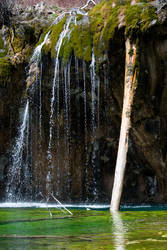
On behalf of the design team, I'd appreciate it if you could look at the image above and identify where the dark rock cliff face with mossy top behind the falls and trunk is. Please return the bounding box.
[0,1,167,203]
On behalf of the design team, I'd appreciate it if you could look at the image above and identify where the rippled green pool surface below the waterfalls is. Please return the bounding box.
[0,206,167,250]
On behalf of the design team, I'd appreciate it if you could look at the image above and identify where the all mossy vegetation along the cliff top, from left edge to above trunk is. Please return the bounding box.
[0,0,158,67]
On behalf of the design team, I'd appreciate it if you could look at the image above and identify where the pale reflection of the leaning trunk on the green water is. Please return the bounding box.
[111,212,126,250]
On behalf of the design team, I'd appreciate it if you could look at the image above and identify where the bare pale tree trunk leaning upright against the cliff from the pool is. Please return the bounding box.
[110,39,137,212]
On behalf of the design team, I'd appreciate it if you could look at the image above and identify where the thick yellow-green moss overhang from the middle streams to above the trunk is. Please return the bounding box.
[38,0,158,63]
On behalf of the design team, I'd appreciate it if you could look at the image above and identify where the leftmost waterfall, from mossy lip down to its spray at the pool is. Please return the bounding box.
[6,32,49,201]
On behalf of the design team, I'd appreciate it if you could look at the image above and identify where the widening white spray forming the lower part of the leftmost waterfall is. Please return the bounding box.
[6,100,29,201]
